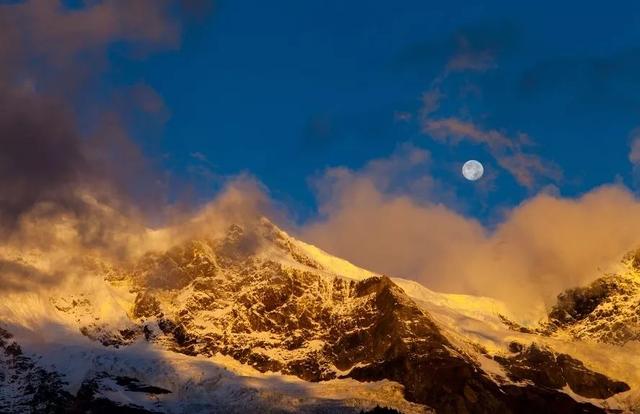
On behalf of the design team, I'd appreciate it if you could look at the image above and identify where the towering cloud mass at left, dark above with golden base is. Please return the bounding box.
[0,0,212,290]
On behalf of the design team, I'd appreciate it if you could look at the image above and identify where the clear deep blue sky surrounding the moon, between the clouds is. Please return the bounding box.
[107,0,640,222]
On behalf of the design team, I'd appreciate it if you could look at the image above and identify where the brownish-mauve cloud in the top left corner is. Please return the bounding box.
[0,0,179,71]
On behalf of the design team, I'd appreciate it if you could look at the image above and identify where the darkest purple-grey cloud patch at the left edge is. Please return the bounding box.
[0,88,93,228]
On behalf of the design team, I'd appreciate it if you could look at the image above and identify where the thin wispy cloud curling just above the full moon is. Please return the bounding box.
[403,21,562,189]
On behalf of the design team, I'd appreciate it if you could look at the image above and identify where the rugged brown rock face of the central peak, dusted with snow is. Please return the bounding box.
[104,223,625,413]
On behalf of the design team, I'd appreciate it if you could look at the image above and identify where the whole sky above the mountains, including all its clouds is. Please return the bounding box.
[6,0,640,307]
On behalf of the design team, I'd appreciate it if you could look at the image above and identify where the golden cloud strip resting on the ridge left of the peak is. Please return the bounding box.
[0,175,270,294]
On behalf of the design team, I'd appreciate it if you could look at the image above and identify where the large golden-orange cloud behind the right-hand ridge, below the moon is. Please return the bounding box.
[299,150,640,311]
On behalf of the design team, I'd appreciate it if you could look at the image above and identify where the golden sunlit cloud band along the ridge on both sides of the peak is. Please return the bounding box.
[1,147,640,318]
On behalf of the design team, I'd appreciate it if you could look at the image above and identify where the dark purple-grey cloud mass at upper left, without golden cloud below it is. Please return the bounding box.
[0,0,211,241]
